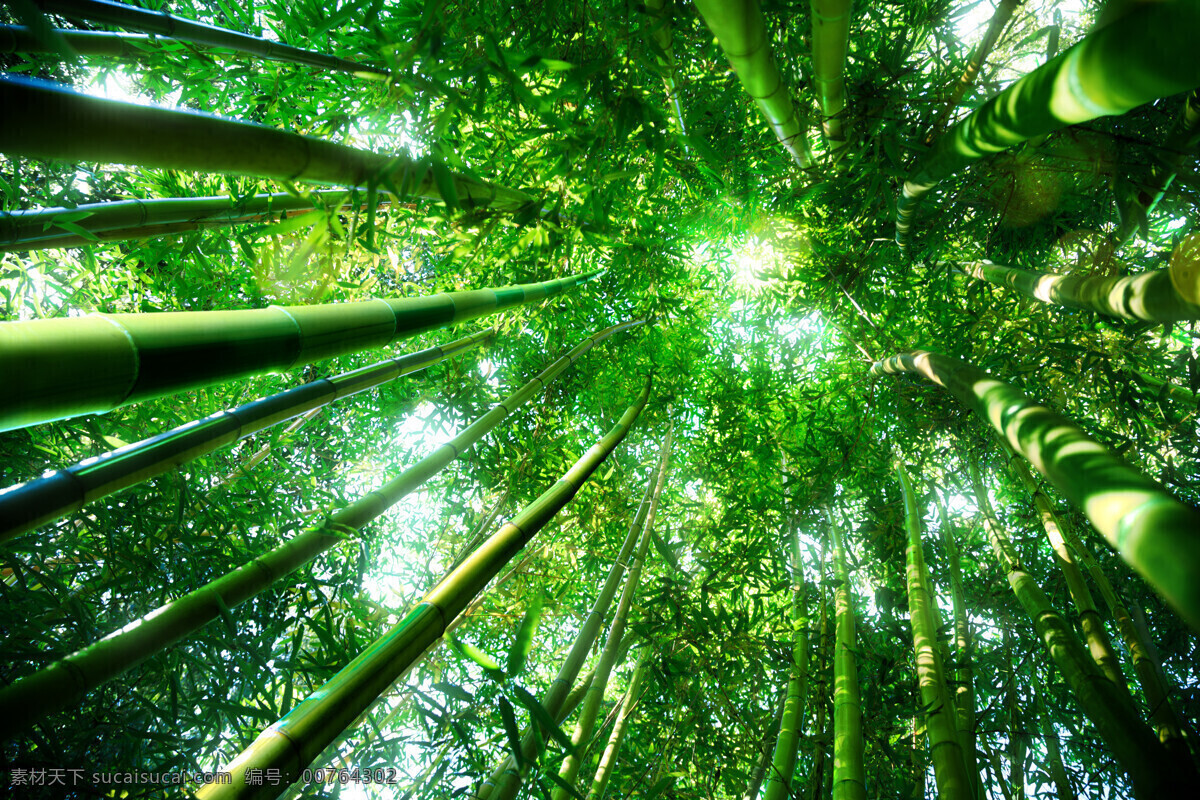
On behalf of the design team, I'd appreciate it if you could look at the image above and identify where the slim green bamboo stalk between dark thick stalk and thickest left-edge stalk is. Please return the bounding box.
[0,190,379,253]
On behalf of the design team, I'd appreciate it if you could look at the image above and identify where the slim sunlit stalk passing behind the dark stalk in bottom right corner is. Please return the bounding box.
[1001,441,1135,709]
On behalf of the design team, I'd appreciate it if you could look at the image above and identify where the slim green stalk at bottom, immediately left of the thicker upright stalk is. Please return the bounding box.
[764,529,809,800]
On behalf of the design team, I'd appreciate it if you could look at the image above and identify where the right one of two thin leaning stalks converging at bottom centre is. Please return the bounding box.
[554,422,672,800]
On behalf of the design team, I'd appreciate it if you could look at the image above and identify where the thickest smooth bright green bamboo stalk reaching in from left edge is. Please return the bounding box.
[0,272,599,431]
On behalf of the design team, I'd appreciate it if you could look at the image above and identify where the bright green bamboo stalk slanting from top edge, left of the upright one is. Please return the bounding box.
[696,0,811,169]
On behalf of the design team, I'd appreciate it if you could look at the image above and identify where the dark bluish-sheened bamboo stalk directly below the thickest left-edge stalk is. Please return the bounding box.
[0,329,494,542]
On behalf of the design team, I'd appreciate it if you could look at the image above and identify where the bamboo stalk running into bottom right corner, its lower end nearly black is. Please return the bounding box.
[967,459,1198,800]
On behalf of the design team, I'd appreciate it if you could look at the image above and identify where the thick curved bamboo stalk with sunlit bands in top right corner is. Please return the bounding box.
[896,0,1200,248]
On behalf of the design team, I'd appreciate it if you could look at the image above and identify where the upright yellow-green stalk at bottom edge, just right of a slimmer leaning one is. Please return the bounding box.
[829,519,866,800]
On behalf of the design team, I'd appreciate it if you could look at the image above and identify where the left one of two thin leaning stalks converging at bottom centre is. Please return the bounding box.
[489,424,671,800]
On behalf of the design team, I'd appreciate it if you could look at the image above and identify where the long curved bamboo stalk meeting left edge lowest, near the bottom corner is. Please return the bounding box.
[0,320,641,735]
